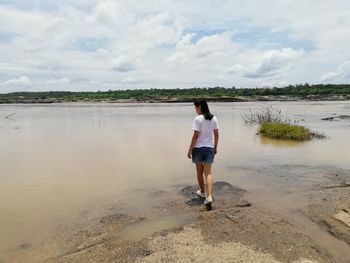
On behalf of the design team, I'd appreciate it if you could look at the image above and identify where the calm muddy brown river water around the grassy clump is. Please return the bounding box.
[0,102,350,260]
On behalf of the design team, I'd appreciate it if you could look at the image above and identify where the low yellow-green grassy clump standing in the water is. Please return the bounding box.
[259,122,324,141]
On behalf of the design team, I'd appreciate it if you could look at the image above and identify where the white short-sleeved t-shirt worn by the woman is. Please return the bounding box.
[192,115,218,148]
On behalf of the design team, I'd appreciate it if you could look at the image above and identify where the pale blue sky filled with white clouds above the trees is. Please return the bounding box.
[0,0,350,93]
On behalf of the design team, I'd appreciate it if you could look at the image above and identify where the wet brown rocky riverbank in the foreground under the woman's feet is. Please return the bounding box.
[6,167,350,263]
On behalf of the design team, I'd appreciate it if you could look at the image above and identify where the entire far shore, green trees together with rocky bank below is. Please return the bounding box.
[0,83,350,104]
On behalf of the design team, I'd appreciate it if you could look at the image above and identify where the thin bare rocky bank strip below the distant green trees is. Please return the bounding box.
[0,94,350,104]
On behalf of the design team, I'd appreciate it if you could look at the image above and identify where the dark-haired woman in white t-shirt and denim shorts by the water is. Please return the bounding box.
[187,99,219,205]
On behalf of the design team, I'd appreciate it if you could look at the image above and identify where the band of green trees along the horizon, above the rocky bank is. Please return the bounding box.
[0,83,350,103]
